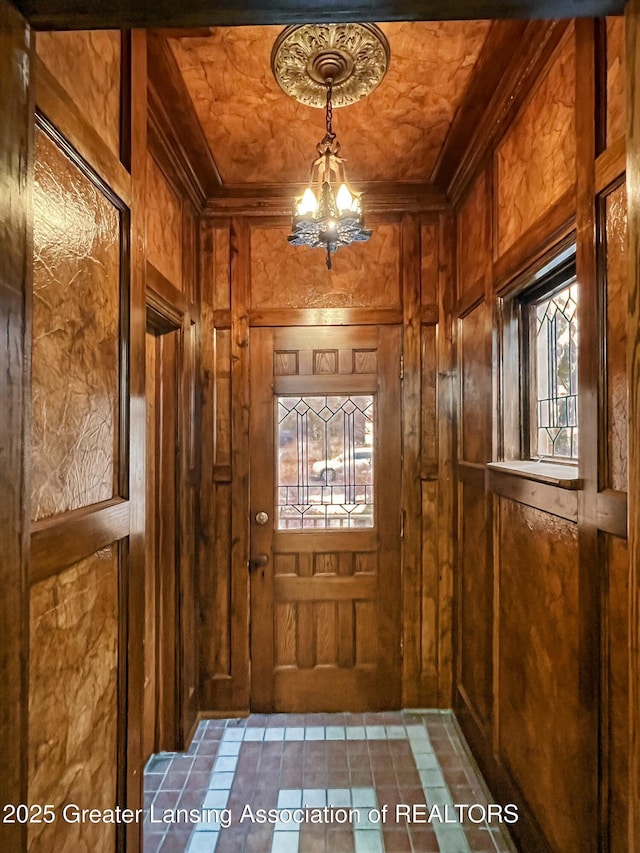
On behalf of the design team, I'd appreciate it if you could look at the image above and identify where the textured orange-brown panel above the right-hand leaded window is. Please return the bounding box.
[495,28,576,256]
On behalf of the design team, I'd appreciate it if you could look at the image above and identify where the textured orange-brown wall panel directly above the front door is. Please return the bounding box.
[251,224,400,310]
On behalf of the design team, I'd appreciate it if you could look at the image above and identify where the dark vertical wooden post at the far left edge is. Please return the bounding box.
[0,5,34,851]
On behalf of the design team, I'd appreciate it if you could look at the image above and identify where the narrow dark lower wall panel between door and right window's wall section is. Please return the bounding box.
[457,481,493,725]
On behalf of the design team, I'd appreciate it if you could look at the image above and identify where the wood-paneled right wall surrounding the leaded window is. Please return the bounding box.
[454,19,629,851]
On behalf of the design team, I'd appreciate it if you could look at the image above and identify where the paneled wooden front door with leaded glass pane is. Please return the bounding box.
[249,326,401,712]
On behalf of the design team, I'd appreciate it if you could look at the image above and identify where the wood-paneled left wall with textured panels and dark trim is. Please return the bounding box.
[0,23,201,851]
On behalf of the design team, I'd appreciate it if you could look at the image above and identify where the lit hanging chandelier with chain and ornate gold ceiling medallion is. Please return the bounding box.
[271,24,389,269]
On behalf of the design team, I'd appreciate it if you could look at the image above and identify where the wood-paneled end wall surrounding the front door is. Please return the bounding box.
[199,213,453,714]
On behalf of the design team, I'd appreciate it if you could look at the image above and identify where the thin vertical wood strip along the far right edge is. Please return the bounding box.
[625,5,640,850]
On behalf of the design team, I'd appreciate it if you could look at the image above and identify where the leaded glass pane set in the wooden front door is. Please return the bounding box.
[276,394,375,530]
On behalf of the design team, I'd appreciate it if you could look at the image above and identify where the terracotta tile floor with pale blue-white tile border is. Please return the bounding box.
[144,711,515,853]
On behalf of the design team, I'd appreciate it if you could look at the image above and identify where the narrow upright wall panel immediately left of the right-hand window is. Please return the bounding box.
[460,302,491,462]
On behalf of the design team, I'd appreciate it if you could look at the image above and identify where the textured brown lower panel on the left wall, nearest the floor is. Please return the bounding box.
[28,546,119,853]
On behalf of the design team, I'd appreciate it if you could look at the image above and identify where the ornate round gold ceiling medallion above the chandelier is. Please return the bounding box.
[271,24,389,108]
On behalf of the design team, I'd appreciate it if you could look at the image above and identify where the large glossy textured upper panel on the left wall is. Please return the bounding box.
[32,125,121,520]
